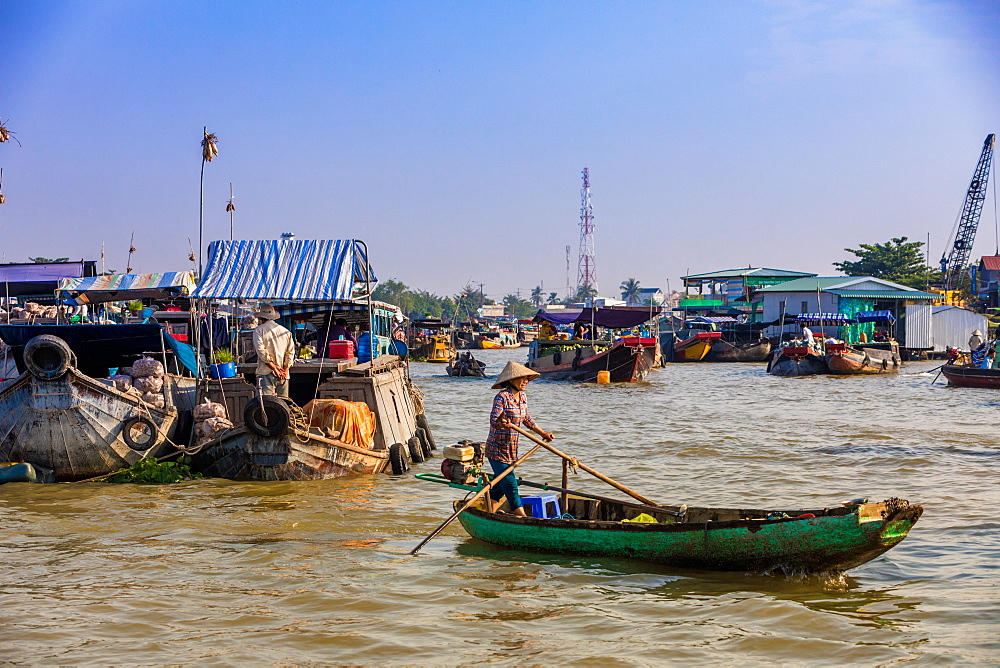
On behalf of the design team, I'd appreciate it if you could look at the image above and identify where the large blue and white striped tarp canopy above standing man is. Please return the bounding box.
[191,239,377,301]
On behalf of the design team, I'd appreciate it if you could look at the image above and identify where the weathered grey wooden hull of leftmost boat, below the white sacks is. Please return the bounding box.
[0,368,186,482]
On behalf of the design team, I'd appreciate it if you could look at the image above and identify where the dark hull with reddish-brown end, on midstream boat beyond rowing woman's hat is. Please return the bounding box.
[527,341,656,383]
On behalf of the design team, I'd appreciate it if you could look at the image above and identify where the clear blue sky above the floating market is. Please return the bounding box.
[0,0,1000,299]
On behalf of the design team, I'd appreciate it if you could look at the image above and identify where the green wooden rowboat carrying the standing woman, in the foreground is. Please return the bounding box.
[421,476,923,573]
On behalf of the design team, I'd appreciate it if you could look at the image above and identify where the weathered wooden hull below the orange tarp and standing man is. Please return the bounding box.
[192,427,389,480]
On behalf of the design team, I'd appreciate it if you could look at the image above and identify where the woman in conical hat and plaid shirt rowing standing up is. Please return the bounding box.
[486,361,555,517]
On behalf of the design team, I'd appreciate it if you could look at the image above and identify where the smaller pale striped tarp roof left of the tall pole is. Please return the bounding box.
[56,271,195,304]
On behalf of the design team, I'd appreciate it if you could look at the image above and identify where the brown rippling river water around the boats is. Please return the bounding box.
[0,349,1000,666]
